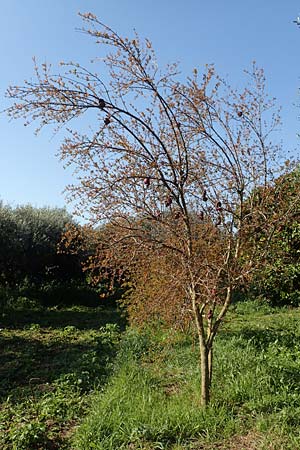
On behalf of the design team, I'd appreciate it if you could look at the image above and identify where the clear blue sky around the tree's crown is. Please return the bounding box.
[0,0,300,214]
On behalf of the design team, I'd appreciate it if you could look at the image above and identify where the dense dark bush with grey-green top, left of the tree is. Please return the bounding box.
[0,203,105,309]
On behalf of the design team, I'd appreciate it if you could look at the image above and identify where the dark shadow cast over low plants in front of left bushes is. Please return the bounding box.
[0,308,125,401]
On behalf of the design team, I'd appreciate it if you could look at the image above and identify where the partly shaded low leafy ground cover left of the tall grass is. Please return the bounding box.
[0,307,122,450]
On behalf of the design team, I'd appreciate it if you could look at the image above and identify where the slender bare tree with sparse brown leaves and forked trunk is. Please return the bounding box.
[4,13,292,405]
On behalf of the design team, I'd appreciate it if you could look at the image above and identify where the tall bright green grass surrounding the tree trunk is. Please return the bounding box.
[74,303,300,450]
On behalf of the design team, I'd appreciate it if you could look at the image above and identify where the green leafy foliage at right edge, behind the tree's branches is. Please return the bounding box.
[247,167,300,306]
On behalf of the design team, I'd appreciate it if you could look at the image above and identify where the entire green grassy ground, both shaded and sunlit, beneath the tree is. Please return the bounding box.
[0,302,300,450]
